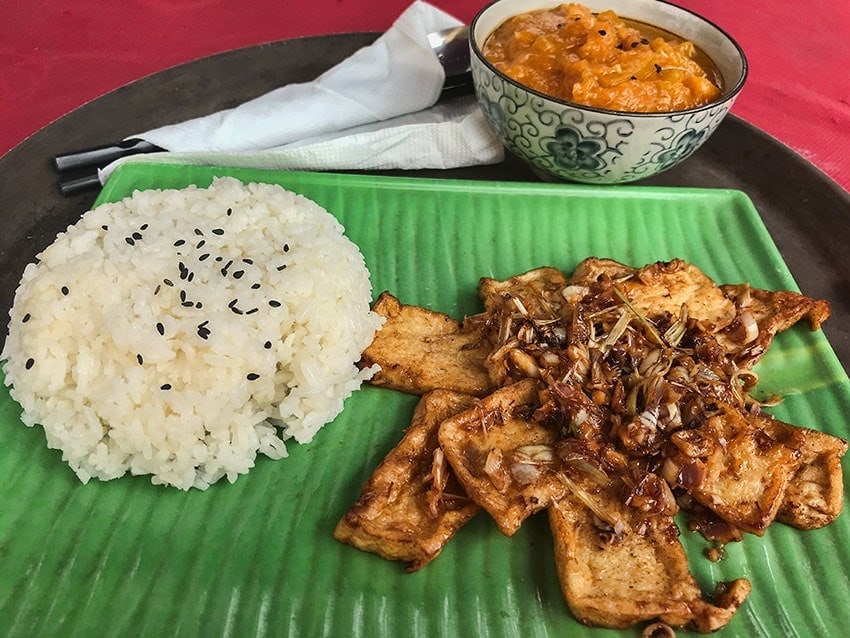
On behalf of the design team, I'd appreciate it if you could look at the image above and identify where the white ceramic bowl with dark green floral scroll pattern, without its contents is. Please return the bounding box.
[470,0,747,184]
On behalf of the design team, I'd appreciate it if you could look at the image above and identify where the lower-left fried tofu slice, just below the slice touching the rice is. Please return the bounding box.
[334,390,480,571]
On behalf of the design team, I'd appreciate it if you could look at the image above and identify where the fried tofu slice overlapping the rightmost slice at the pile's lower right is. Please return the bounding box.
[663,403,802,536]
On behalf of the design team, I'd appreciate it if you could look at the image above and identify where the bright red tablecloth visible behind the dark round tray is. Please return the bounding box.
[0,0,850,189]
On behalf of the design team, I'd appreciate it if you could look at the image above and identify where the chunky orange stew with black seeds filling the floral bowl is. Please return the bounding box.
[483,4,721,112]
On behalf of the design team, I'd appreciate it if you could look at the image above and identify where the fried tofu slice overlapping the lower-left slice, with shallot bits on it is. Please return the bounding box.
[439,379,566,536]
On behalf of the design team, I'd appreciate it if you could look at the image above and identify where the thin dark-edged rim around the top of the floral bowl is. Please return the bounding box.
[469,0,749,118]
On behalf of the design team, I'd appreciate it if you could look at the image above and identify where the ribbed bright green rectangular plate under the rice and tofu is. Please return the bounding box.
[0,164,850,637]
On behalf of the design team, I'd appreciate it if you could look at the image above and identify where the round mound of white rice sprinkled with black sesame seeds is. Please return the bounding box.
[0,178,381,489]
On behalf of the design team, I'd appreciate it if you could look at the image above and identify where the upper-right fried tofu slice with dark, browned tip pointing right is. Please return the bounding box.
[717,284,831,367]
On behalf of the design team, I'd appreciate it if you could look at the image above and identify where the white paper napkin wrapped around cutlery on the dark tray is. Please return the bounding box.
[100,0,504,182]
